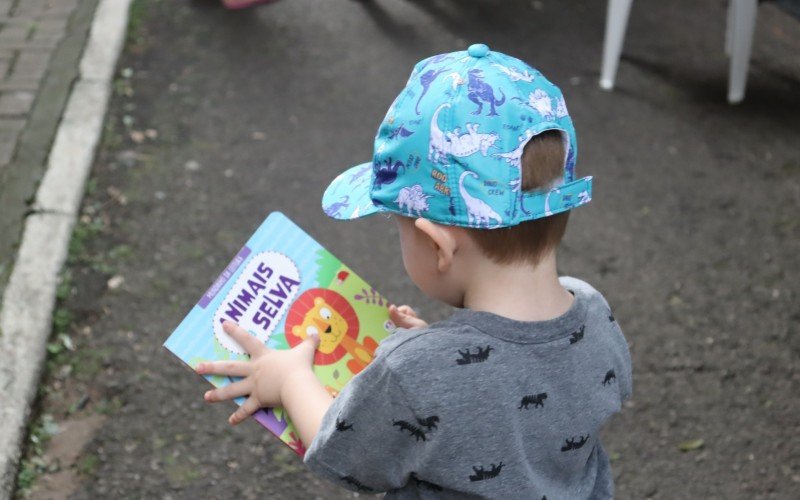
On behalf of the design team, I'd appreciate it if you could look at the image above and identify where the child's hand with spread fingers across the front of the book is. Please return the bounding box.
[196,321,319,425]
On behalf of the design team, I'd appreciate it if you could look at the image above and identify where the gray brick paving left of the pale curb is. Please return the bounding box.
[0,0,97,292]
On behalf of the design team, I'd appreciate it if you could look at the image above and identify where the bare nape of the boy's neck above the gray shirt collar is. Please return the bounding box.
[464,252,574,321]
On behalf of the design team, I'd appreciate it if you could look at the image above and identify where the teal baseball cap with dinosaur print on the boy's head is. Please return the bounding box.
[322,44,592,229]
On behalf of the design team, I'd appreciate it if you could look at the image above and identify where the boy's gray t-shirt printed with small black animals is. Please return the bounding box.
[305,278,631,500]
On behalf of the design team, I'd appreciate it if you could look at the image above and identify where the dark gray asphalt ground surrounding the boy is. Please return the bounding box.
[10,0,800,499]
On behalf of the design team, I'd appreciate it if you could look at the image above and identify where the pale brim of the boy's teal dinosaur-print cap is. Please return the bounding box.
[322,163,385,220]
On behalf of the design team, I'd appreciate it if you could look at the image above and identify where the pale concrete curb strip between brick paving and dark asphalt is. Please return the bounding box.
[0,0,132,499]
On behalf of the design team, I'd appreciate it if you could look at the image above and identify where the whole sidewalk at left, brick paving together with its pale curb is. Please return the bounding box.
[0,0,129,498]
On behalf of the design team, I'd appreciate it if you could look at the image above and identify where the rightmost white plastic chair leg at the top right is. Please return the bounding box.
[728,0,758,104]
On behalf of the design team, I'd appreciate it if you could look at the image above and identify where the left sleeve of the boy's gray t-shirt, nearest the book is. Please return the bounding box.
[304,356,424,493]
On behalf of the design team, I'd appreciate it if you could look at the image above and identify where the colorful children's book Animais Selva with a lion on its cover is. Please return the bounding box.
[164,212,394,456]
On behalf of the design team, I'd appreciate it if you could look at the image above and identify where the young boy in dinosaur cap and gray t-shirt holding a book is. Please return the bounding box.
[198,45,631,500]
